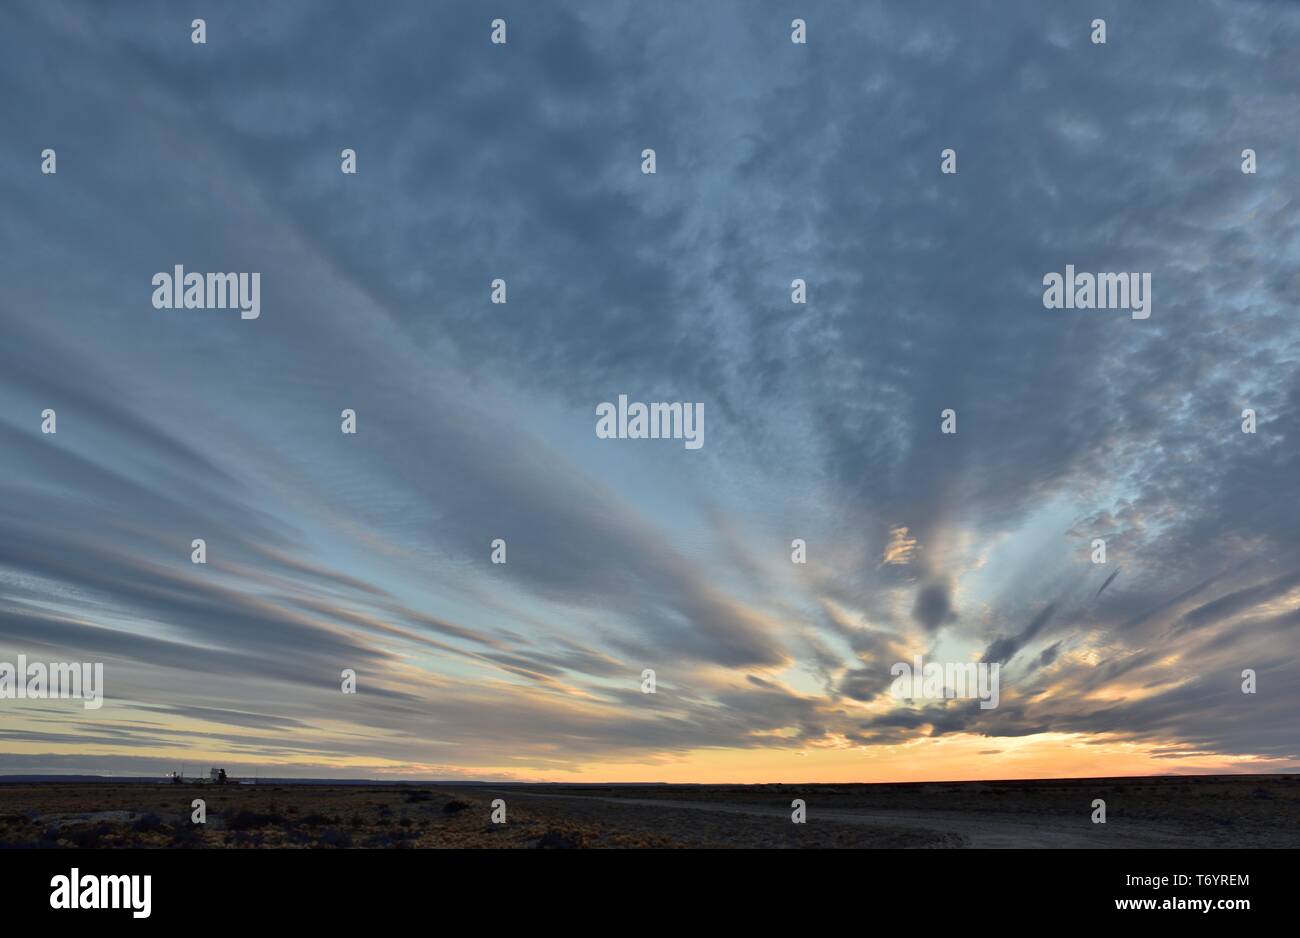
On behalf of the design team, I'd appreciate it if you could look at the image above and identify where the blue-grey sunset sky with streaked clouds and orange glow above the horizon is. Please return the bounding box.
[0,0,1300,782]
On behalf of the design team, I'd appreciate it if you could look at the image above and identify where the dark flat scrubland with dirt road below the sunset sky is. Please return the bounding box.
[0,776,1300,848]
